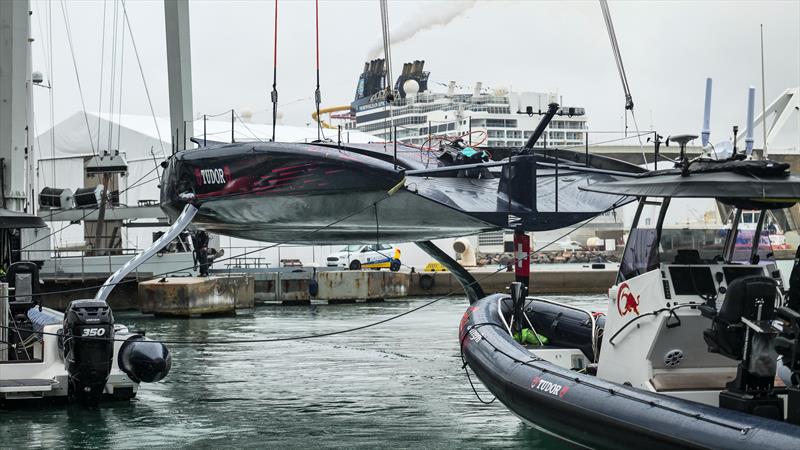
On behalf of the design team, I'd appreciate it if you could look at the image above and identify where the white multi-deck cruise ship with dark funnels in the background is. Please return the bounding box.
[347,59,587,147]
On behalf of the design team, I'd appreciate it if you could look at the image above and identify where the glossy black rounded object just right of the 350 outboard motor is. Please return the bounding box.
[117,334,172,383]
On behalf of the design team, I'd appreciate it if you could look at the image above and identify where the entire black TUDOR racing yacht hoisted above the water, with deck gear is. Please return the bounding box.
[161,104,644,243]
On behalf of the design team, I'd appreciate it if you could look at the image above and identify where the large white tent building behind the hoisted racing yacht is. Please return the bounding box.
[35,111,450,267]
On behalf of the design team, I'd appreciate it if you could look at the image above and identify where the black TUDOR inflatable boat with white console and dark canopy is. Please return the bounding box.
[459,154,800,449]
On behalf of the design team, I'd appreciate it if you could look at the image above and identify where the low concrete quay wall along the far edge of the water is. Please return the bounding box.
[36,265,616,317]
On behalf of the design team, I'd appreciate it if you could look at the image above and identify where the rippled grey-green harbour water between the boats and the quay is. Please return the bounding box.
[0,297,604,449]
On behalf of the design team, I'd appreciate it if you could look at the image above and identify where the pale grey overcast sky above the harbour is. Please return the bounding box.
[32,0,800,146]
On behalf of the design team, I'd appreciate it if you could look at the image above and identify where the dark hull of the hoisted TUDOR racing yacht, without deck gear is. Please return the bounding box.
[161,143,640,244]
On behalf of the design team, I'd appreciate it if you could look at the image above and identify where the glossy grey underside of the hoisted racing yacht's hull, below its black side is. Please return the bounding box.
[194,190,497,244]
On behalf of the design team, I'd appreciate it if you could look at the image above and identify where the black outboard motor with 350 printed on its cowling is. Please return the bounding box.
[64,300,114,404]
